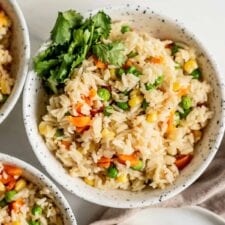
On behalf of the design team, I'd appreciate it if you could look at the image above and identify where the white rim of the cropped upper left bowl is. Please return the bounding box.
[0,0,30,124]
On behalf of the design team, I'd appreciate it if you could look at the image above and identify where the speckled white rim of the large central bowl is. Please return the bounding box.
[23,3,225,208]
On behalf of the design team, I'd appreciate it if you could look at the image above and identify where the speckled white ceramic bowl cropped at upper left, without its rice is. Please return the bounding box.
[0,0,30,123]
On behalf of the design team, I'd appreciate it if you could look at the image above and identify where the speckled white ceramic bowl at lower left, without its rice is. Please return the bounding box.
[0,153,77,225]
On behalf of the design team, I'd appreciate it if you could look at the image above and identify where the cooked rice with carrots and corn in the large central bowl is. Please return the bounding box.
[39,22,212,191]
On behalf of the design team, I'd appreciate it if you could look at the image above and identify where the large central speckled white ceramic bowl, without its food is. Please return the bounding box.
[23,4,225,208]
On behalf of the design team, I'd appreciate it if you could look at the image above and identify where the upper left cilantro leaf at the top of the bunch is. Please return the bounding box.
[51,10,83,45]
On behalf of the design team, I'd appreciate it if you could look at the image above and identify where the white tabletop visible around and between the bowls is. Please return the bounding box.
[0,0,225,225]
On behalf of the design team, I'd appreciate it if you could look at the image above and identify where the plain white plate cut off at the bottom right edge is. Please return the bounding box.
[118,207,225,225]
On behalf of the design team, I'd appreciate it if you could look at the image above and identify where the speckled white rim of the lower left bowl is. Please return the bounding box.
[0,153,77,225]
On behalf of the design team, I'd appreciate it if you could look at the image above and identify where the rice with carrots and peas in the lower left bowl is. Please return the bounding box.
[0,163,63,225]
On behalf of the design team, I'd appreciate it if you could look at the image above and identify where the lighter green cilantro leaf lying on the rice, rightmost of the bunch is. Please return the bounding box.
[92,41,126,66]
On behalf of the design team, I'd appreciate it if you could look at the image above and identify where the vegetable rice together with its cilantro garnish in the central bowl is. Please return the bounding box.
[34,10,212,191]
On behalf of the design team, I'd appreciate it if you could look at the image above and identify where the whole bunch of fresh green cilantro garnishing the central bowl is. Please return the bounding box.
[34,10,125,93]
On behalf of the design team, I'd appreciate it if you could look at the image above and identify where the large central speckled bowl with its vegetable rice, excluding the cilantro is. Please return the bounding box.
[23,5,224,208]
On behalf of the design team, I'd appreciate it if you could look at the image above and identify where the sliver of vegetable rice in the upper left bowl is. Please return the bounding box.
[0,9,14,105]
